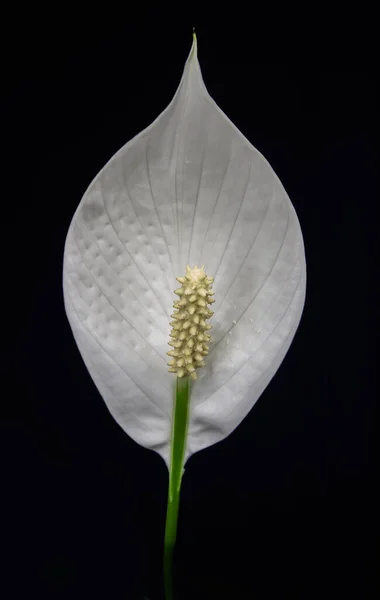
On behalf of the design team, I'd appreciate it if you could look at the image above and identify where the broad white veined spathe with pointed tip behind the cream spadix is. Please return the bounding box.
[63,37,306,464]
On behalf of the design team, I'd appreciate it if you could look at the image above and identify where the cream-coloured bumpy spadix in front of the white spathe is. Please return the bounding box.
[167,265,215,379]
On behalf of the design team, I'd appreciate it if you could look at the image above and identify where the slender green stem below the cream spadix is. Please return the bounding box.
[164,377,190,600]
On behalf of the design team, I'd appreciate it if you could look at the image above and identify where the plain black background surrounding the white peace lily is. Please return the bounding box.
[2,14,377,600]
